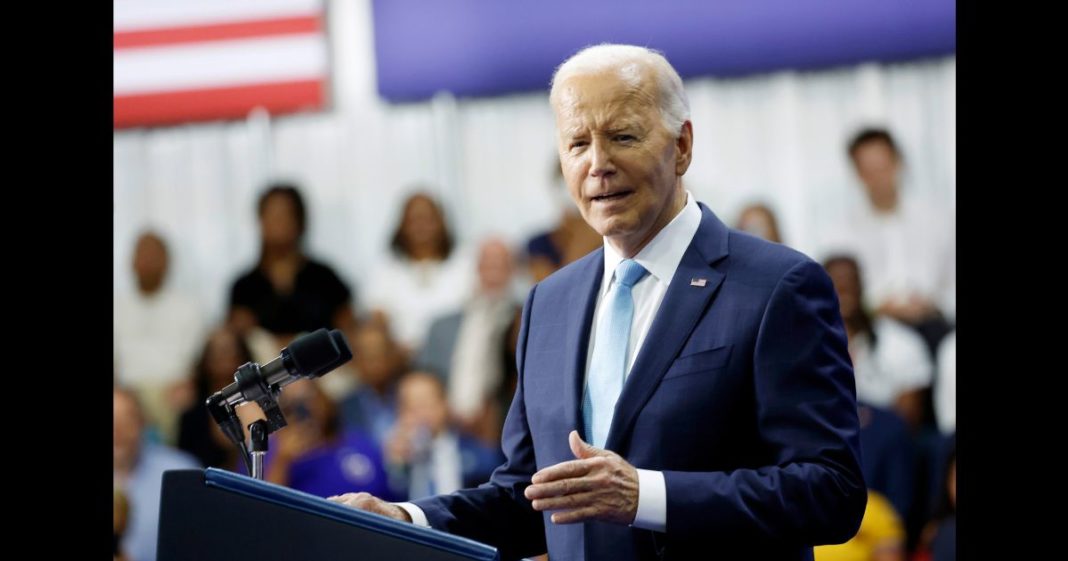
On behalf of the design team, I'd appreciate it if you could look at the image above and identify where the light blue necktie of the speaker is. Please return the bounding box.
[582,259,648,448]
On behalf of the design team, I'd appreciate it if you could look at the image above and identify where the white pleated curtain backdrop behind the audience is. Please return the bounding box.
[114,0,956,329]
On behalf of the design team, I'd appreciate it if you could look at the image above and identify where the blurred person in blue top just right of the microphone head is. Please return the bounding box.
[339,321,408,445]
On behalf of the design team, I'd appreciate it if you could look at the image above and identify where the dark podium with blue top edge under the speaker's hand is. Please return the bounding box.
[157,468,499,561]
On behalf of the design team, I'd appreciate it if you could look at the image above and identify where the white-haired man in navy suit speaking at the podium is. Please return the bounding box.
[334,45,867,561]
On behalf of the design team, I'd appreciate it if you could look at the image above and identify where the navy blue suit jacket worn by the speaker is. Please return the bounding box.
[415,205,867,561]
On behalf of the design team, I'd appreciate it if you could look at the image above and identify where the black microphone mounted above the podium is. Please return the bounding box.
[207,329,352,448]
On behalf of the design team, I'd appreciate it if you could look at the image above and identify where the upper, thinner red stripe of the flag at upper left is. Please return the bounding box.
[114,15,321,50]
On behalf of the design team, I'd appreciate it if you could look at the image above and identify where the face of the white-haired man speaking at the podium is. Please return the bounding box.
[553,71,692,253]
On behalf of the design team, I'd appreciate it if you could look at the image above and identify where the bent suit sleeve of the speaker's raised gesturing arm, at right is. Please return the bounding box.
[664,260,867,545]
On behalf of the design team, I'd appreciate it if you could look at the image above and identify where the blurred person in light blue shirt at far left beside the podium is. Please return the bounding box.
[112,387,200,561]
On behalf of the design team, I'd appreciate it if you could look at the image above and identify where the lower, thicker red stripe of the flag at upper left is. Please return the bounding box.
[113,80,324,128]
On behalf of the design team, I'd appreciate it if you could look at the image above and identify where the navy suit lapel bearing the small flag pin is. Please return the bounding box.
[606,205,728,453]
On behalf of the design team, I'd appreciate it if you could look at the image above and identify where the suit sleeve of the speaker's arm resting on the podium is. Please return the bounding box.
[412,285,546,560]
